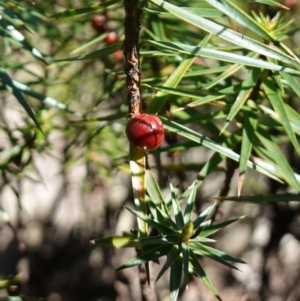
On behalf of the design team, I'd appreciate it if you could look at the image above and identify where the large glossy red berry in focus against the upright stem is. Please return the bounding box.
[126,114,165,151]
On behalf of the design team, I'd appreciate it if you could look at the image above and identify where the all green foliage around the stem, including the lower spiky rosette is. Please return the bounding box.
[0,0,300,300]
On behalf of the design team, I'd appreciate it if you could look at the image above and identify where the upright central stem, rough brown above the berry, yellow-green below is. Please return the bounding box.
[123,0,157,301]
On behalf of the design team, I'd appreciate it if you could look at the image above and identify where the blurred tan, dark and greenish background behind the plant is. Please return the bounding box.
[0,0,300,301]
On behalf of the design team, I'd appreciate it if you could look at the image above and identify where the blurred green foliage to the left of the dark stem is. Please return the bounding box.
[0,1,127,187]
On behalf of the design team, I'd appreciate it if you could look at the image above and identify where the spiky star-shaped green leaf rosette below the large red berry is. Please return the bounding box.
[93,172,243,300]
